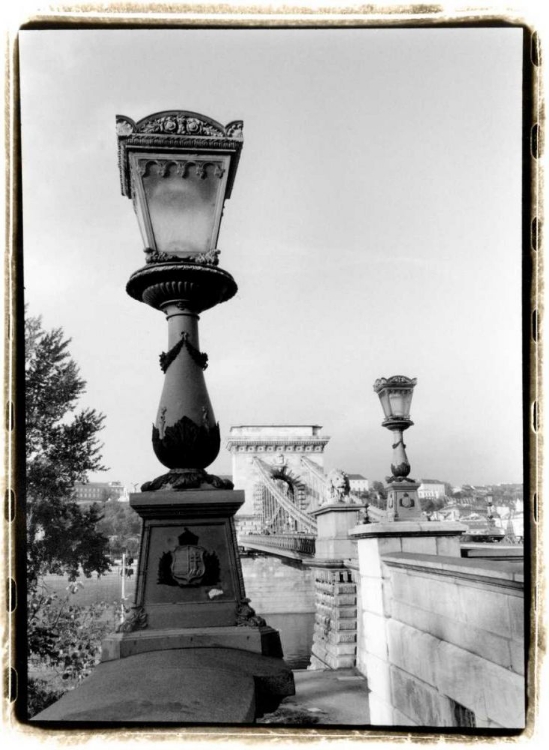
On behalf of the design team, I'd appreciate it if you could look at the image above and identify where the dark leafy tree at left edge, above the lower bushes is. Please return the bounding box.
[25,317,109,590]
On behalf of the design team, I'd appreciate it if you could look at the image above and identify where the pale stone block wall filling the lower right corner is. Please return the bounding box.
[357,552,525,728]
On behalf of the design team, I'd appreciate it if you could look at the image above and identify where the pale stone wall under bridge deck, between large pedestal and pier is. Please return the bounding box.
[240,555,315,614]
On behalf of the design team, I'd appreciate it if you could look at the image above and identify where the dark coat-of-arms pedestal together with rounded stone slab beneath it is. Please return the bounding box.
[38,489,295,725]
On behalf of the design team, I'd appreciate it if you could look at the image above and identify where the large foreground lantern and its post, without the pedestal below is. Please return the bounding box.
[116,110,243,491]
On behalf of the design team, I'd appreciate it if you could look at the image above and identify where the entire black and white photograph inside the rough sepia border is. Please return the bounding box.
[9,10,533,739]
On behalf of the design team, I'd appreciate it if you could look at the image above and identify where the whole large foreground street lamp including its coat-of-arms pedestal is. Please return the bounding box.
[108,111,286,668]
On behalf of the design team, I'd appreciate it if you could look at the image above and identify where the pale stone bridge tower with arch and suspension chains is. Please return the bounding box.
[227,425,330,533]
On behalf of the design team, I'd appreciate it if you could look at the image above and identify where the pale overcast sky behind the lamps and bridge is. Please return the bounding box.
[21,28,522,484]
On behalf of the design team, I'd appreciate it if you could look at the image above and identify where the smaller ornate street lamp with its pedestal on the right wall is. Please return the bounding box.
[374,375,421,520]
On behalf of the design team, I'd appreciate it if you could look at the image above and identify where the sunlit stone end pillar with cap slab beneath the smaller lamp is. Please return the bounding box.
[350,521,465,725]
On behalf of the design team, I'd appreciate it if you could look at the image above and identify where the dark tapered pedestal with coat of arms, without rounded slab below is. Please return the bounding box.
[102,490,282,661]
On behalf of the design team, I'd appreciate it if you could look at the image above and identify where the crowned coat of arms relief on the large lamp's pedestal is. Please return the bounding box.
[158,529,219,586]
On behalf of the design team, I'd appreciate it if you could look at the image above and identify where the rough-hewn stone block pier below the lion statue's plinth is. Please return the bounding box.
[310,567,357,669]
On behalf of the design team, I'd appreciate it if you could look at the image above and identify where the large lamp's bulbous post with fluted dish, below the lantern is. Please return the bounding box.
[127,261,237,491]
